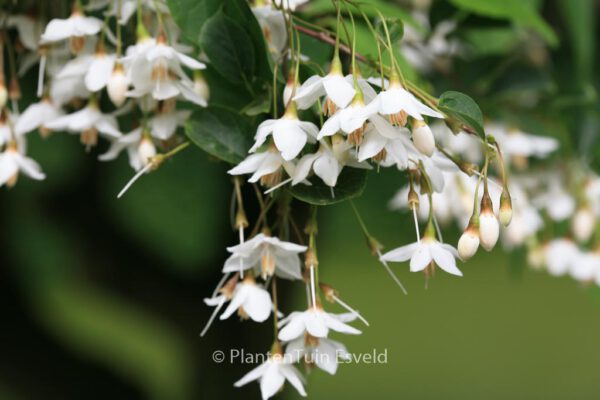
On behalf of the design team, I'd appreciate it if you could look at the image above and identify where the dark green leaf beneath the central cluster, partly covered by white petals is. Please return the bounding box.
[289,168,367,206]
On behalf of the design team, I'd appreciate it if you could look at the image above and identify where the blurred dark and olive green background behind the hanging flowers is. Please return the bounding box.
[0,0,600,400]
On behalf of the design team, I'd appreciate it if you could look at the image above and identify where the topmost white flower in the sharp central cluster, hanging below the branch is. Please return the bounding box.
[292,60,356,114]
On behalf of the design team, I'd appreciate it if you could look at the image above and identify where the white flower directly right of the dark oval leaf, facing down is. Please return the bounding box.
[250,108,319,161]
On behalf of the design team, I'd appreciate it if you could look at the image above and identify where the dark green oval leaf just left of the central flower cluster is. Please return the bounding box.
[185,107,255,164]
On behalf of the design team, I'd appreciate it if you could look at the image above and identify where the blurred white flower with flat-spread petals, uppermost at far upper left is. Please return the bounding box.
[40,10,102,44]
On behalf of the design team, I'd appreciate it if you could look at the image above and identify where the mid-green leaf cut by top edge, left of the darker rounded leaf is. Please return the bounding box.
[167,0,222,45]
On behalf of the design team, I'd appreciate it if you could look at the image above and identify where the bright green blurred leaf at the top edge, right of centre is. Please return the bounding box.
[450,0,558,46]
